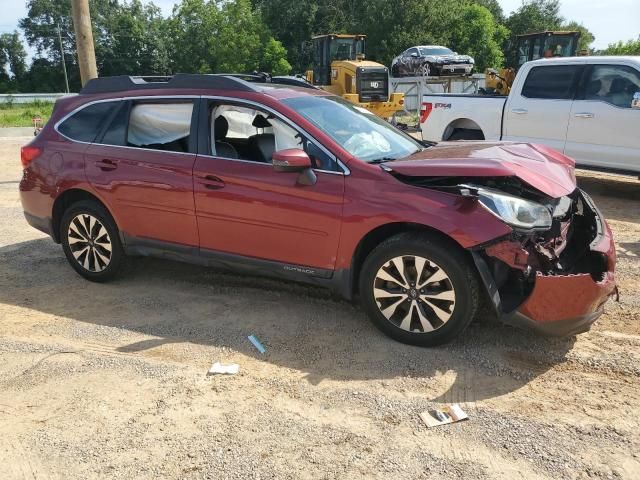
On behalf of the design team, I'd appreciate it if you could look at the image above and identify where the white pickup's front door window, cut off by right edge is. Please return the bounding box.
[584,65,640,108]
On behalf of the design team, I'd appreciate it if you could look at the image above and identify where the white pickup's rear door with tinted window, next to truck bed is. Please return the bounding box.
[503,63,584,152]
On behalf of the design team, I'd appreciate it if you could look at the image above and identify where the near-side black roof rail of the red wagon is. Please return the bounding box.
[80,73,257,94]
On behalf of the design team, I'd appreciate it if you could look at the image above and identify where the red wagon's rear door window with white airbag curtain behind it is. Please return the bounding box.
[127,102,193,152]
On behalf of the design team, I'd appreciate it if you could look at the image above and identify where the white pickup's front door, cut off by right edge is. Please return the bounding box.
[565,63,640,172]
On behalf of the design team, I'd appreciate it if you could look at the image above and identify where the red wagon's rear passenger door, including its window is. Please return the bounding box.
[85,98,198,248]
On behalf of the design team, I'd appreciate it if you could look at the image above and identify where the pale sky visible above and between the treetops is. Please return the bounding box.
[0,0,640,61]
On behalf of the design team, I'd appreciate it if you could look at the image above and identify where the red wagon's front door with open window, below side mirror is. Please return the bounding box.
[194,101,344,270]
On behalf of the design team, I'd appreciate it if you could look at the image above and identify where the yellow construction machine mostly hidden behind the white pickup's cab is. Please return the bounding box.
[481,31,580,95]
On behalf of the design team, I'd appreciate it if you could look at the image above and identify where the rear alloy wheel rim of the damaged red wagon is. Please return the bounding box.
[67,213,113,272]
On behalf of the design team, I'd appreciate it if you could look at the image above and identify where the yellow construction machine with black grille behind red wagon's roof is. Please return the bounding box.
[305,34,404,118]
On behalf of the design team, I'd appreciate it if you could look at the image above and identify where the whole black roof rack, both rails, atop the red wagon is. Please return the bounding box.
[80,73,316,94]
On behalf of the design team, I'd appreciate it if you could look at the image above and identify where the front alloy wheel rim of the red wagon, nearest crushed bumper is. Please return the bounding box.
[373,255,456,333]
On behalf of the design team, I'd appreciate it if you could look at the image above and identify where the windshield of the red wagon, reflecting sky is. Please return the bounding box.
[282,96,423,162]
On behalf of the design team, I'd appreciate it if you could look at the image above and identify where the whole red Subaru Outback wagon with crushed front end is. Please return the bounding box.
[20,75,616,345]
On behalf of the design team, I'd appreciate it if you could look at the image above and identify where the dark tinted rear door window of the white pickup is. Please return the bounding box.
[522,65,582,100]
